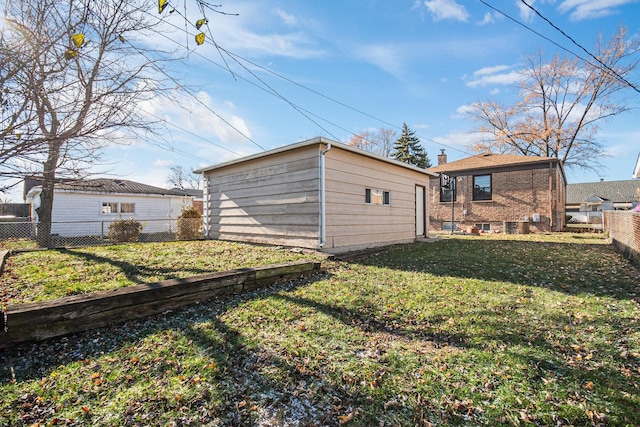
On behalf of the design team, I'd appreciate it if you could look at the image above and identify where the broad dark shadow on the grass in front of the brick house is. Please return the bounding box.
[357,238,640,300]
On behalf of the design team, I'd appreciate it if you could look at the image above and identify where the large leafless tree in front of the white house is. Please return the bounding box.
[0,0,178,246]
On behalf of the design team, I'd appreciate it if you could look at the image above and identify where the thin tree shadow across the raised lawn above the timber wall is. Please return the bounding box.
[52,249,211,284]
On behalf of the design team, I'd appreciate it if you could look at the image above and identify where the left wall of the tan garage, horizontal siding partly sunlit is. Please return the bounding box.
[207,146,320,247]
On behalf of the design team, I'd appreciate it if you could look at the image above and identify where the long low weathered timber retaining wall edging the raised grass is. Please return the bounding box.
[0,261,320,348]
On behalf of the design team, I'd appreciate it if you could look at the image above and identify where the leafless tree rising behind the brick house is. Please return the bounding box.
[469,28,640,170]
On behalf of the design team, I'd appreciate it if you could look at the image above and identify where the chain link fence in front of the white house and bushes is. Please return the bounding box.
[0,218,203,249]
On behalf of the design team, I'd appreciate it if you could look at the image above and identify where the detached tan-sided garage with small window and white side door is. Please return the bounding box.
[195,138,437,252]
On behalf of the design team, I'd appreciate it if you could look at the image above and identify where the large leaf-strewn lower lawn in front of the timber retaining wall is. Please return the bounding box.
[0,235,640,426]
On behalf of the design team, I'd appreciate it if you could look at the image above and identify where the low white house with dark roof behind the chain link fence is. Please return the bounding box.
[26,179,193,237]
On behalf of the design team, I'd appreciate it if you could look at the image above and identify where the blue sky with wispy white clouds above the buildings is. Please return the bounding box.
[5,0,640,201]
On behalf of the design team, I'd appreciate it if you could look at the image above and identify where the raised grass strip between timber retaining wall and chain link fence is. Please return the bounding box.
[0,240,320,305]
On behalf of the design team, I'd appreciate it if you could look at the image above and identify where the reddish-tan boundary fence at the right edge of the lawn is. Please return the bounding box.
[604,211,640,264]
